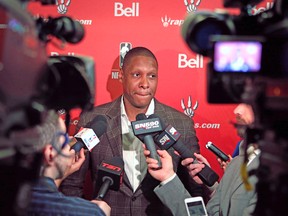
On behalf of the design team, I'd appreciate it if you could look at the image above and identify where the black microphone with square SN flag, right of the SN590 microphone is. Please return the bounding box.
[155,122,219,187]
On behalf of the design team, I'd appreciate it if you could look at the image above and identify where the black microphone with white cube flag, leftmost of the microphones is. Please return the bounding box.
[71,115,107,152]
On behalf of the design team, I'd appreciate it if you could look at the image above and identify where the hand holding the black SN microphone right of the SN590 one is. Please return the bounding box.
[181,153,210,184]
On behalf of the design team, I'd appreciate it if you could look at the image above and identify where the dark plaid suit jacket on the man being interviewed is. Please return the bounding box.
[60,97,203,216]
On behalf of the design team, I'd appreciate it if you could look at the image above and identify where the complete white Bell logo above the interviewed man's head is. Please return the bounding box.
[114,2,139,17]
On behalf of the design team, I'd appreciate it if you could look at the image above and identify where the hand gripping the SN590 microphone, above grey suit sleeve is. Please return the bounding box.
[144,149,175,182]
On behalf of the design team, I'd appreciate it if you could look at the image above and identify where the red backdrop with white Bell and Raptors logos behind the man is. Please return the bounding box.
[27,0,273,175]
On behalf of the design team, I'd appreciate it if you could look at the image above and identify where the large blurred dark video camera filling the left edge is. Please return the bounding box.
[0,0,95,215]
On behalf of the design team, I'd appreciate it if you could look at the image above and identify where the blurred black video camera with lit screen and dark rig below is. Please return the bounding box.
[182,0,288,216]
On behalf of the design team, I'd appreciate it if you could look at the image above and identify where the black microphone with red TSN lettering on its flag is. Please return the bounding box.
[96,157,124,200]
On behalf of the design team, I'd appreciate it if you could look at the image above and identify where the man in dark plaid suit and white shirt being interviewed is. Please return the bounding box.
[61,47,202,216]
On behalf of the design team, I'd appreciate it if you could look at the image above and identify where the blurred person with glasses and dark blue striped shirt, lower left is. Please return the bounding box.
[13,111,111,216]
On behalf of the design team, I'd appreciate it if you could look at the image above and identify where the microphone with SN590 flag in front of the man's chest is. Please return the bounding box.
[131,113,163,168]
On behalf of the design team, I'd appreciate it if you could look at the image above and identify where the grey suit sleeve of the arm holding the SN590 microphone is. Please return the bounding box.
[154,176,191,216]
